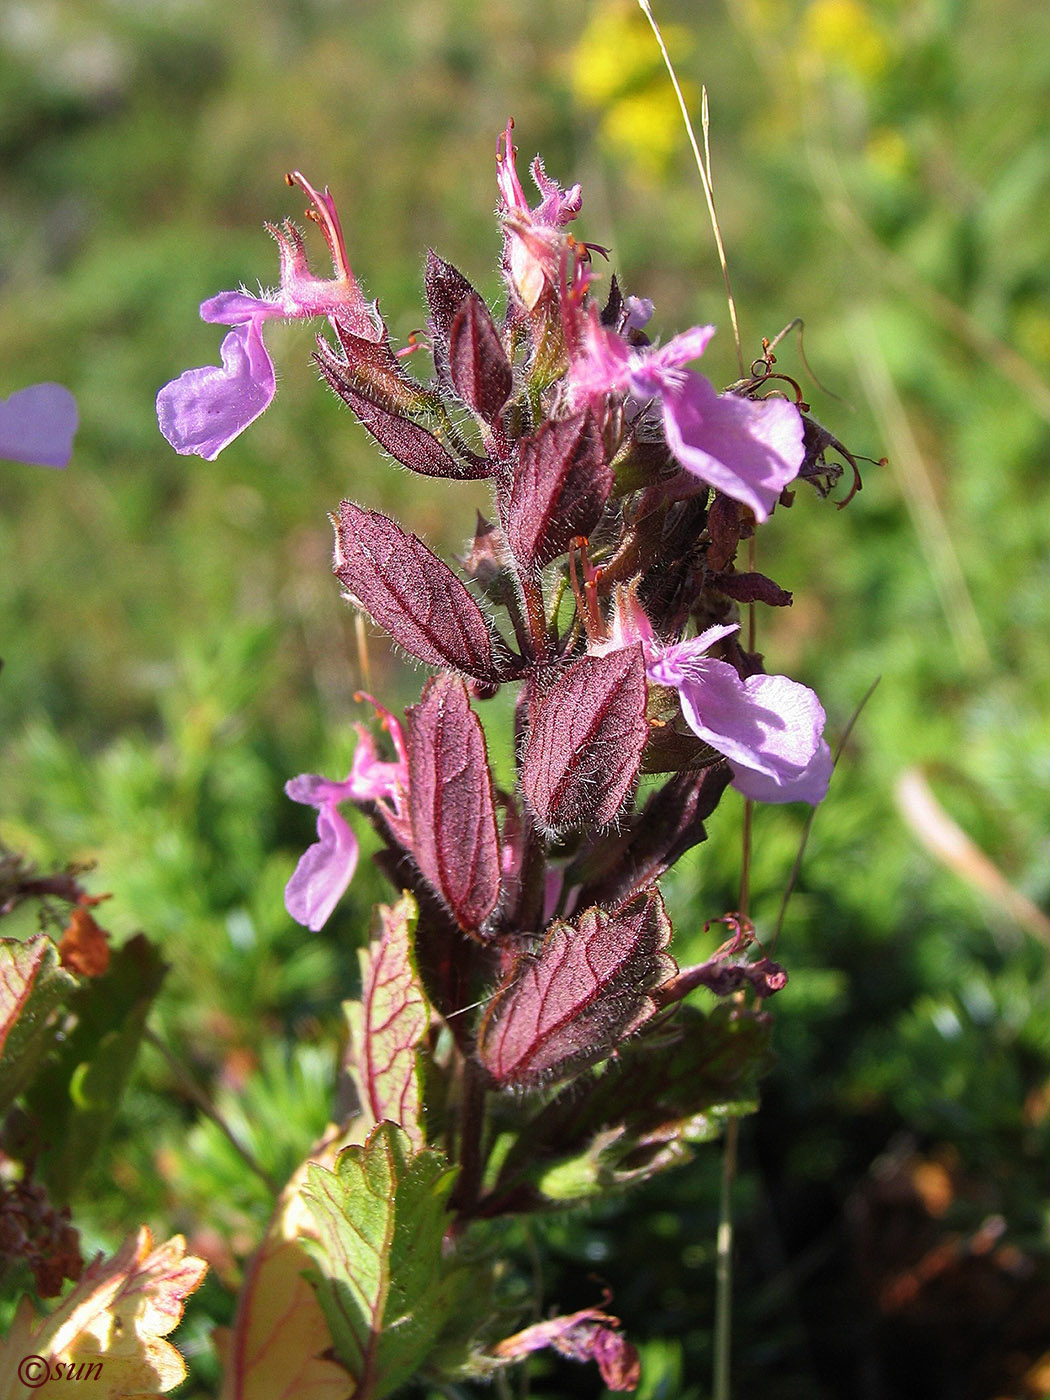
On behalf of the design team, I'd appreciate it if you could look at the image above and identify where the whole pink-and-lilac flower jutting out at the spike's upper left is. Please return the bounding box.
[157,171,384,462]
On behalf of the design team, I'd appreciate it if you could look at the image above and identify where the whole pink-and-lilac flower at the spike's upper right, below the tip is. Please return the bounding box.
[568,315,805,521]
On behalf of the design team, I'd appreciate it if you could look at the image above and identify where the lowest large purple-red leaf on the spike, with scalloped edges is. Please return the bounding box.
[479,889,676,1085]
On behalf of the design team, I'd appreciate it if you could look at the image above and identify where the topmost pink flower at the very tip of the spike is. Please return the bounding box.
[496,120,584,311]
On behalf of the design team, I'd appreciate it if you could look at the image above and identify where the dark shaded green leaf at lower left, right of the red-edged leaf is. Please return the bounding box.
[25,934,167,1203]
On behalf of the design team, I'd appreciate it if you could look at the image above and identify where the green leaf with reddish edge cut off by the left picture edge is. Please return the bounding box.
[0,934,77,1114]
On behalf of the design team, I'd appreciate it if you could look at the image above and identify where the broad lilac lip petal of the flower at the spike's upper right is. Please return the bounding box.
[661,370,804,521]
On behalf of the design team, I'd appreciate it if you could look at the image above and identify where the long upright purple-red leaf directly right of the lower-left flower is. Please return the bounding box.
[406,675,500,932]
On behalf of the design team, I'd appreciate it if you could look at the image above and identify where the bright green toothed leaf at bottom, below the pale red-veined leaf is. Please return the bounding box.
[304,1123,458,1400]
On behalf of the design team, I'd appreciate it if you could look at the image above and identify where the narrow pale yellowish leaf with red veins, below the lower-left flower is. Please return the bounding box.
[347,895,430,1151]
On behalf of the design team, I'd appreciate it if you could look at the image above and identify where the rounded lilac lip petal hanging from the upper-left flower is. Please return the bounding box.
[157,319,277,462]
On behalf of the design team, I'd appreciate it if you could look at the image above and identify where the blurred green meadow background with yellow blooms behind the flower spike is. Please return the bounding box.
[0,0,1050,1400]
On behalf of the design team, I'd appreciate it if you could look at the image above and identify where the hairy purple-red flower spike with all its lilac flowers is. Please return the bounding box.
[157,125,856,1383]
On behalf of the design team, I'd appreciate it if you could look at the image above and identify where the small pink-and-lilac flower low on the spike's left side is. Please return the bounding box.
[284,706,407,932]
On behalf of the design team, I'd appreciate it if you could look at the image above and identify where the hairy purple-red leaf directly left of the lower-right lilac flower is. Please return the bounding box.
[521,647,648,830]
